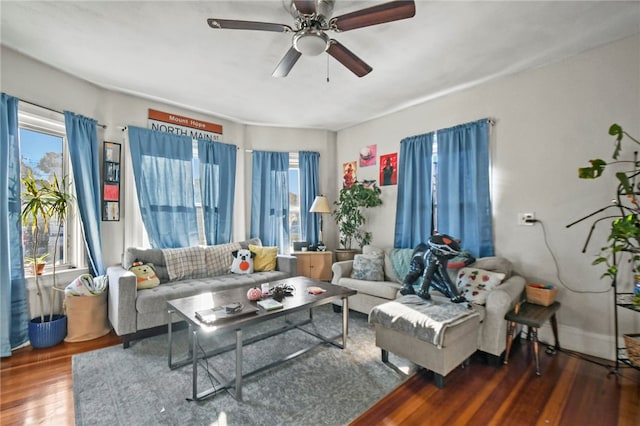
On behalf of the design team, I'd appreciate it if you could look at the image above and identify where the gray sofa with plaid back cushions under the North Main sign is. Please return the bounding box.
[107,239,297,348]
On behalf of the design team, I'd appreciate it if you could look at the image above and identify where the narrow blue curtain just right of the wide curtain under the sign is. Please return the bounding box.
[198,139,238,245]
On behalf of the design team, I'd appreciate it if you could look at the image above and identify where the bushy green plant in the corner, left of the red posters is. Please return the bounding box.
[332,181,382,261]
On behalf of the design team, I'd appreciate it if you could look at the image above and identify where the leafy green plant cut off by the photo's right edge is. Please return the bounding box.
[572,124,640,280]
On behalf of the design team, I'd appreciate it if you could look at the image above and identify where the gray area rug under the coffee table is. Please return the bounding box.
[72,305,406,426]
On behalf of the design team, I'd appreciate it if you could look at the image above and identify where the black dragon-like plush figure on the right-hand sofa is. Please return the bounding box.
[400,234,473,303]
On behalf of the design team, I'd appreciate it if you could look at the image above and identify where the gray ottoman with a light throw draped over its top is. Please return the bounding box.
[369,295,480,388]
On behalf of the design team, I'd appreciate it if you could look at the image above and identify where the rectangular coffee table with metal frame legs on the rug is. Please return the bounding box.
[167,277,357,401]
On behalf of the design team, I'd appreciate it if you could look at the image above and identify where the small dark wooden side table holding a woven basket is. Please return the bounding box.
[504,302,560,376]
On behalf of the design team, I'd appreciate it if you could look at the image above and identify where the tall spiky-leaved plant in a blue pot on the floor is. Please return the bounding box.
[20,171,73,348]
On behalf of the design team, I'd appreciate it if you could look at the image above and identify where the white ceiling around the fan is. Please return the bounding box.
[0,0,640,130]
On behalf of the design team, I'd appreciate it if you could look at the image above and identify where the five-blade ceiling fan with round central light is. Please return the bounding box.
[207,0,416,77]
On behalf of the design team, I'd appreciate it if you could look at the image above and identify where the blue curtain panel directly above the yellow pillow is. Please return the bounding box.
[251,151,290,253]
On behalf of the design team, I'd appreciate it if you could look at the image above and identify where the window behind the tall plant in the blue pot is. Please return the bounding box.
[18,103,86,276]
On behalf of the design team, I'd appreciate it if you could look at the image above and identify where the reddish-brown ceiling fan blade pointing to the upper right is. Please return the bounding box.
[331,0,416,31]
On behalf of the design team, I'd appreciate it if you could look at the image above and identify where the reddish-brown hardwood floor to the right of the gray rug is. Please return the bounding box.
[351,340,640,426]
